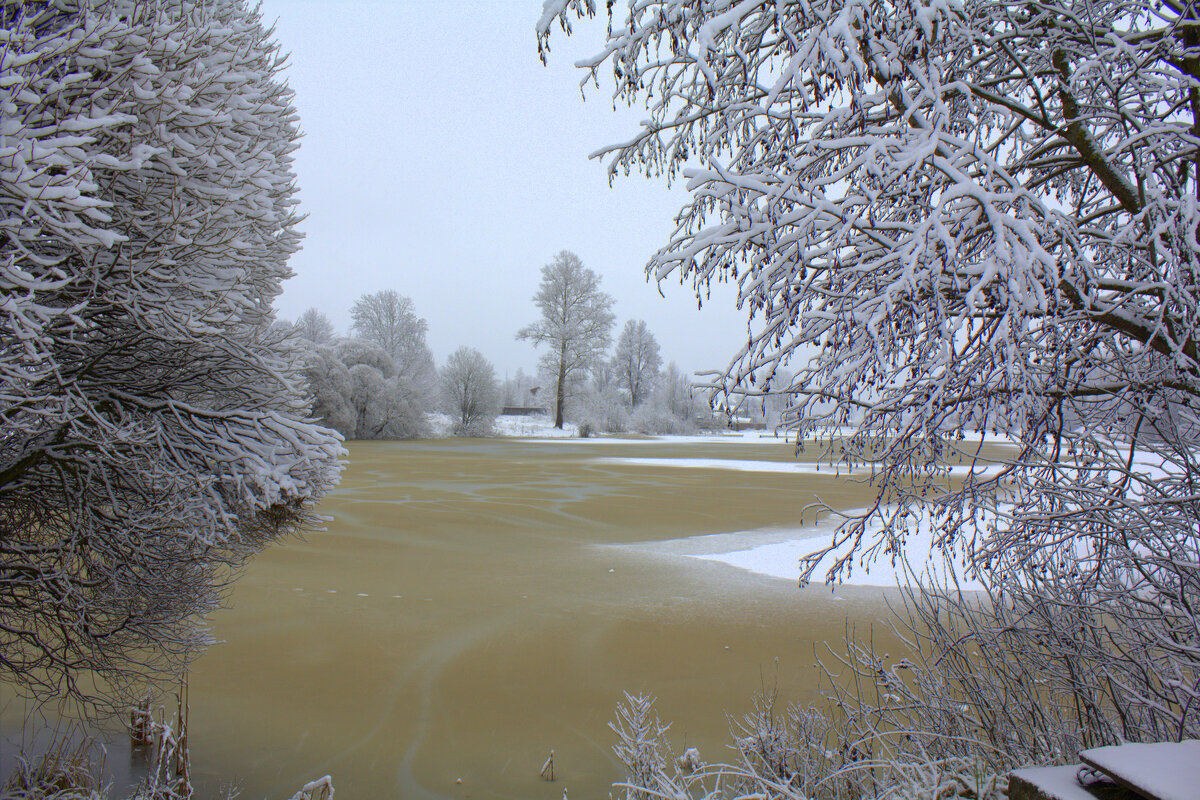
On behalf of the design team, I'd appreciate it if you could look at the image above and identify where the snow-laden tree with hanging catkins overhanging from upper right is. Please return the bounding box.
[540,0,1200,563]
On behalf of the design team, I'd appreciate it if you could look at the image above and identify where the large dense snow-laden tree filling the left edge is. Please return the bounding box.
[0,0,341,697]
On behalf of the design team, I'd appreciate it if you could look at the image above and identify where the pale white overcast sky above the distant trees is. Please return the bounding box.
[262,0,746,378]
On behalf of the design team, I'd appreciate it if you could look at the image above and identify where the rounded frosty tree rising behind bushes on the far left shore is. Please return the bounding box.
[350,289,437,402]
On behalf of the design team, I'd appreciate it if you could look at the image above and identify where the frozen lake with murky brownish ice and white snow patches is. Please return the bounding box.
[2,437,1012,800]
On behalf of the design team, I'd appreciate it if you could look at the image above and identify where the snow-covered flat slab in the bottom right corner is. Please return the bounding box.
[1079,739,1200,800]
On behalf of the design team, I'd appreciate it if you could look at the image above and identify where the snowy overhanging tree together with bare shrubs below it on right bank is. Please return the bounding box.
[538,0,1200,798]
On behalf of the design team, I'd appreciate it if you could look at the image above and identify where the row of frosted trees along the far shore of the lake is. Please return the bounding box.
[291,251,712,439]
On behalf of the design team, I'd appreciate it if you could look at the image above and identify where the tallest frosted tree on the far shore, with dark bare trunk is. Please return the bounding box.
[517,249,613,428]
